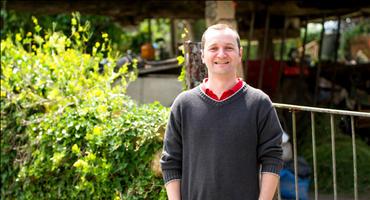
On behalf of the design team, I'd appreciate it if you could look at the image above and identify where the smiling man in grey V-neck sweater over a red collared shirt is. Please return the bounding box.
[161,24,283,200]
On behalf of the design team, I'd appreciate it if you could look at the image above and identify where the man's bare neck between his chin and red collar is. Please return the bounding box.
[206,75,238,97]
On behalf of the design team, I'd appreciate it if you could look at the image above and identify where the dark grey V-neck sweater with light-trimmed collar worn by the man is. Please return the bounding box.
[161,83,283,200]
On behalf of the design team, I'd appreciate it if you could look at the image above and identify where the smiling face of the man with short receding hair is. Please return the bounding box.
[202,29,242,75]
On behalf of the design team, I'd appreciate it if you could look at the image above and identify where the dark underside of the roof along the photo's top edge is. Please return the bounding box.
[6,0,370,24]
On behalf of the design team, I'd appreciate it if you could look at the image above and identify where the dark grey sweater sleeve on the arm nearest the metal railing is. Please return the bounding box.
[257,97,283,175]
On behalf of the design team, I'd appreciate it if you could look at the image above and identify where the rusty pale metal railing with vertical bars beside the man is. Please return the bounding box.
[273,103,370,200]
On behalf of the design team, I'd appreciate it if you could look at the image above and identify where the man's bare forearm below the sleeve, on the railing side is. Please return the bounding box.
[259,173,279,200]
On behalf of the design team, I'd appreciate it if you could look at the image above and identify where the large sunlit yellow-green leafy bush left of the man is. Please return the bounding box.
[0,13,168,199]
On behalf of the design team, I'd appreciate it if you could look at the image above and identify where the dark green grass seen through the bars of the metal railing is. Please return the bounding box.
[298,115,370,194]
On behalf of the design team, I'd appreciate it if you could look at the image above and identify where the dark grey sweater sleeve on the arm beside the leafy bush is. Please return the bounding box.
[160,101,182,184]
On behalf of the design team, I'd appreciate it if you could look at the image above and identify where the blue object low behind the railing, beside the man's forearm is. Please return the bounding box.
[280,169,310,200]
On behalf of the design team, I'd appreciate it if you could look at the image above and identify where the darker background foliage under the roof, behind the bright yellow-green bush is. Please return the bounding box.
[0,10,149,54]
